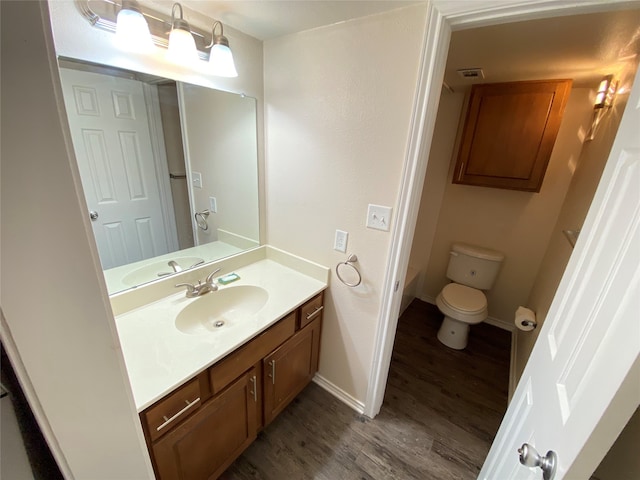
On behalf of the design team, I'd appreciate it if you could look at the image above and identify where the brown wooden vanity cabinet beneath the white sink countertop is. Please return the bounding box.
[140,293,323,480]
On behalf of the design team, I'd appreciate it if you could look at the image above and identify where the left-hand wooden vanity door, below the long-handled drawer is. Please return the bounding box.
[153,369,258,480]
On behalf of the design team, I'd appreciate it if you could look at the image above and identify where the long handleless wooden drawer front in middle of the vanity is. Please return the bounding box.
[209,312,296,394]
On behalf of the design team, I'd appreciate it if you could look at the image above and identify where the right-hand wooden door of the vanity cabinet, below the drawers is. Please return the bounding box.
[263,318,321,425]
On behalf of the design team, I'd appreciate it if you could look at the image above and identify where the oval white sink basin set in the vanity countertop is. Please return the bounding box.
[176,285,269,335]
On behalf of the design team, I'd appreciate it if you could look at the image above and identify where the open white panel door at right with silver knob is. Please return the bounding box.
[479,64,640,480]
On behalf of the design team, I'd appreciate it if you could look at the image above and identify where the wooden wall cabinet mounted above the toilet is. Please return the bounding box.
[453,80,572,192]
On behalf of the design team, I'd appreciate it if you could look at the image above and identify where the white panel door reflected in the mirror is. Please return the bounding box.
[60,68,171,269]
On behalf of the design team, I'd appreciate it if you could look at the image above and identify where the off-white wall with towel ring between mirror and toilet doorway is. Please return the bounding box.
[264,5,426,404]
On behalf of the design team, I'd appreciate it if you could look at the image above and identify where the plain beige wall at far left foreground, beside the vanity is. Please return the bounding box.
[0,2,153,479]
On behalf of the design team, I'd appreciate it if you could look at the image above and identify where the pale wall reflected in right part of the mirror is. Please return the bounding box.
[178,84,260,245]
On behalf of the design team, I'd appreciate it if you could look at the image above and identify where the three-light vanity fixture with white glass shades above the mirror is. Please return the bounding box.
[77,0,238,77]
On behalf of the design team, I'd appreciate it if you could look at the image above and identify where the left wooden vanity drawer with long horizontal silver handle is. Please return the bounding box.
[142,377,202,441]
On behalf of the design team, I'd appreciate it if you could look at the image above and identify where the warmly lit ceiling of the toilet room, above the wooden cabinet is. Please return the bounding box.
[445,9,640,90]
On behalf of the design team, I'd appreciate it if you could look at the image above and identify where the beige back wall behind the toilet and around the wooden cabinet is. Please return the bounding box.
[413,88,593,325]
